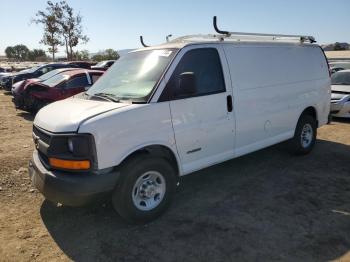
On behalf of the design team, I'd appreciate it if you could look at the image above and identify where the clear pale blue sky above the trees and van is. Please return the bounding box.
[0,0,350,56]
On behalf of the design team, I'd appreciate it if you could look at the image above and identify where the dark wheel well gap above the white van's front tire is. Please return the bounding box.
[121,145,180,176]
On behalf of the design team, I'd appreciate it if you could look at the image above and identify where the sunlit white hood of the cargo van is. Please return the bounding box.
[34,97,130,133]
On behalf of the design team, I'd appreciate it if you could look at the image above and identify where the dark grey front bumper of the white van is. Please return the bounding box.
[28,151,119,206]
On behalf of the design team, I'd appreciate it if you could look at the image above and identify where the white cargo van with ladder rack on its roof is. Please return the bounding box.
[29,18,331,222]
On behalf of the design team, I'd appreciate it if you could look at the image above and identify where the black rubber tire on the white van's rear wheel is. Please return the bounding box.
[288,114,317,155]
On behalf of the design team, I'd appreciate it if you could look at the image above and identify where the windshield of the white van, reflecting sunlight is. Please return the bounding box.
[86,49,176,102]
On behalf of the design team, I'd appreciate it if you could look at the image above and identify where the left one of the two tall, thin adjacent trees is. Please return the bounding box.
[32,1,62,60]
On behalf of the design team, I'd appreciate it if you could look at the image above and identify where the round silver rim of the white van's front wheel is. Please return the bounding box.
[132,171,166,211]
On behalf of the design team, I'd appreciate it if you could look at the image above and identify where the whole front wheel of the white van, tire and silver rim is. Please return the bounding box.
[112,156,176,223]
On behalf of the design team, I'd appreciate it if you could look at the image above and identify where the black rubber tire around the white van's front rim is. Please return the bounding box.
[112,156,176,223]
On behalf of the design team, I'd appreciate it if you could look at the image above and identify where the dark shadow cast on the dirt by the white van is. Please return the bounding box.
[40,140,350,261]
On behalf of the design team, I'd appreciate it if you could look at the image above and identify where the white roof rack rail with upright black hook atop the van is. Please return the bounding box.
[213,16,316,43]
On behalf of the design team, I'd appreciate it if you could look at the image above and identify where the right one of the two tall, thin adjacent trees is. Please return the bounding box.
[56,1,89,60]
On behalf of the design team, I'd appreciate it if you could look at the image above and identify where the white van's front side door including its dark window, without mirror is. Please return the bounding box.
[161,47,235,173]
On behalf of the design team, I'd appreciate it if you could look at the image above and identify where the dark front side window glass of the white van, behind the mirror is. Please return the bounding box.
[160,48,226,101]
